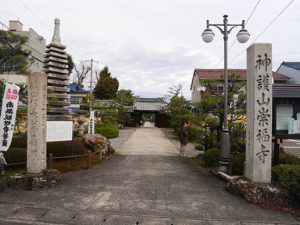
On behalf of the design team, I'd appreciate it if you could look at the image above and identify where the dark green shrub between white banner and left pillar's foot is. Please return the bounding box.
[4,148,27,170]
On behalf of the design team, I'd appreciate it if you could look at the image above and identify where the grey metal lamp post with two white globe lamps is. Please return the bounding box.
[202,15,250,173]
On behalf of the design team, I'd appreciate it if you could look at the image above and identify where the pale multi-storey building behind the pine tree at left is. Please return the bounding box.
[0,20,46,84]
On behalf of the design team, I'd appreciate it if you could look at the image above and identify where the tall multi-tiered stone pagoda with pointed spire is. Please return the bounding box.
[44,19,72,121]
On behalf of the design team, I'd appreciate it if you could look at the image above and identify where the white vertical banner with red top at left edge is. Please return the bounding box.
[0,84,20,151]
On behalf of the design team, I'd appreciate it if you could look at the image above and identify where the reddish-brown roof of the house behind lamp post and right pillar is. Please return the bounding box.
[194,69,290,80]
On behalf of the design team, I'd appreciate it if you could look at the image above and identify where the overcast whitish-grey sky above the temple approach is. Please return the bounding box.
[0,0,300,99]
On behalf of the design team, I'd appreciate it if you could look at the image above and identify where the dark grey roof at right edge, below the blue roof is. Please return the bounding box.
[273,84,300,98]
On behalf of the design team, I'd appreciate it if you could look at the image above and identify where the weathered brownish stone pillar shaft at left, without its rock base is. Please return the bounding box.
[27,72,47,173]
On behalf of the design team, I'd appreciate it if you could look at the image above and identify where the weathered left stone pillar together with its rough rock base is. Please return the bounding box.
[8,71,61,190]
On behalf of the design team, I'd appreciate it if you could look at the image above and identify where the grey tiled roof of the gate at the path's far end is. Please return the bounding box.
[133,98,164,111]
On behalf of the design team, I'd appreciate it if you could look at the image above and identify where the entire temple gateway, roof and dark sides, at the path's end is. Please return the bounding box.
[132,98,170,128]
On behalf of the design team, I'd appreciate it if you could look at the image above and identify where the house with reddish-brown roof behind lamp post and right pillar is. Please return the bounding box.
[190,69,290,103]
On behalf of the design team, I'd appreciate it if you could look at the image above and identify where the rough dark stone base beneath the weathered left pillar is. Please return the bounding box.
[7,169,61,191]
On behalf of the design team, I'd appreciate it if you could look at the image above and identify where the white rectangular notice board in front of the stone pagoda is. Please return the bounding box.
[47,120,73,142]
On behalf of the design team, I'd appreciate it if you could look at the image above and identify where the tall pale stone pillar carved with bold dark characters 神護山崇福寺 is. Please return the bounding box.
[245,43,272,183]
